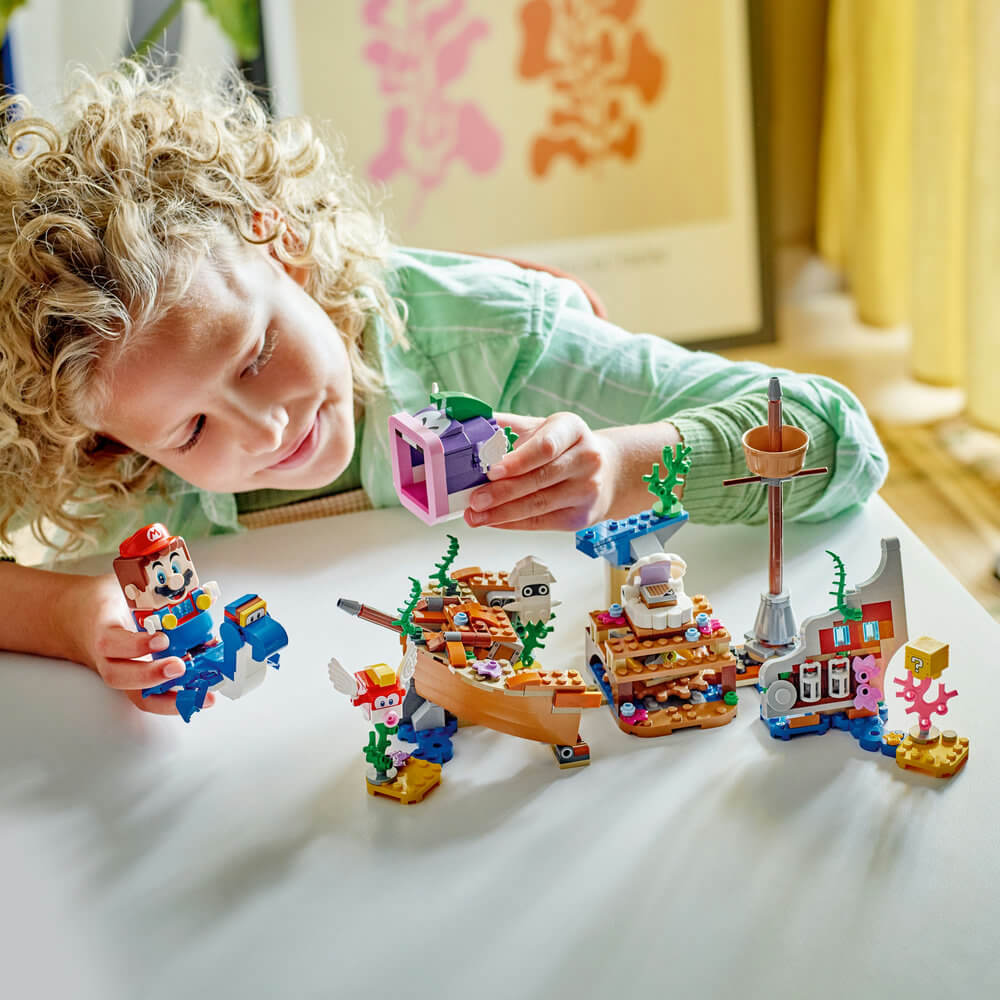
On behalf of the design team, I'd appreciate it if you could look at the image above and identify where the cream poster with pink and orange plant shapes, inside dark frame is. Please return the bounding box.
[293,0,770,346]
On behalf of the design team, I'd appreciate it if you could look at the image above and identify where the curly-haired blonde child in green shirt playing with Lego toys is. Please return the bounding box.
[0,64,886,713]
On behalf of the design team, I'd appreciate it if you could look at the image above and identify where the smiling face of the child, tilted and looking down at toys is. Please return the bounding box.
[91,246,354,493]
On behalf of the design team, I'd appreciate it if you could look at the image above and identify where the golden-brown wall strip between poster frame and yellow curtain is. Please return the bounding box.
[761,0,827,246]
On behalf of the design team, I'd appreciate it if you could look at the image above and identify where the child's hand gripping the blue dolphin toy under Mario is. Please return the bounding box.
[64,574,215,715]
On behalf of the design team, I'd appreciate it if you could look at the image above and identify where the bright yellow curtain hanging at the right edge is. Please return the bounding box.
[817,0,1000,431]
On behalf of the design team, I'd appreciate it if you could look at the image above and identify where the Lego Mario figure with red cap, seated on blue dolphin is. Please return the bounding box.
[114,524,219,660]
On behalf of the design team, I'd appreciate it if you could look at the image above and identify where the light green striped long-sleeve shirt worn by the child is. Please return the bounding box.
[64,250,887,546]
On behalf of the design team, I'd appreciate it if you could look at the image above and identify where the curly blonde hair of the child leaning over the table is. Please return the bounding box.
[0,62,402,552]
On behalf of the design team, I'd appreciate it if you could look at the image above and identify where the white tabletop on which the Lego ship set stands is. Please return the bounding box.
[0,501,1000,1000]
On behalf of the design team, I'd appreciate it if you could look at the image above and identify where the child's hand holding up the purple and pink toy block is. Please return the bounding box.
[465,413,620,531]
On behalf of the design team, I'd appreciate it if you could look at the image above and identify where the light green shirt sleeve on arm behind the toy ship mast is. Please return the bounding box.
[500,275,888,523]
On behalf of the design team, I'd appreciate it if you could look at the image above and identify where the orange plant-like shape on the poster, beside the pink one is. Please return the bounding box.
[518,0,666,177]
